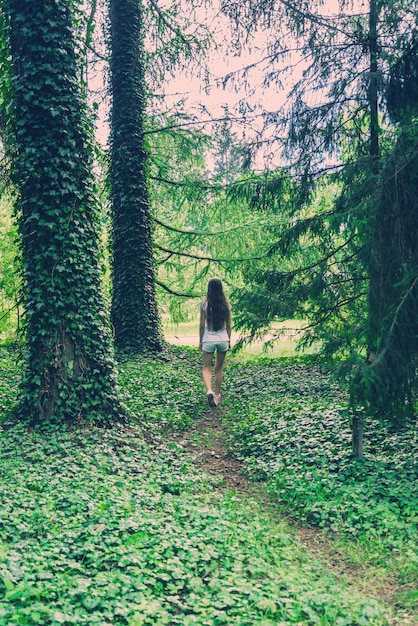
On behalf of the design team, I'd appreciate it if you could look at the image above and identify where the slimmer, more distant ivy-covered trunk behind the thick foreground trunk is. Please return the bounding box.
[109,0,162,354]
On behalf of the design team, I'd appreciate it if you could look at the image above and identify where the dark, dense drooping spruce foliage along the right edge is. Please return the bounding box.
[363,39,418,426]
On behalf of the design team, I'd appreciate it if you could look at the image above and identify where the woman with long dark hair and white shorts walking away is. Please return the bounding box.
[199,278,231,407]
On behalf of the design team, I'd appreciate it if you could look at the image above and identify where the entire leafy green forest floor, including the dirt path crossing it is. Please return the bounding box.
[0,347,418,626]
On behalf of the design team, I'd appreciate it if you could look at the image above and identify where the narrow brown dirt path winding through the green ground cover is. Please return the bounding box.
[169,407,418,626]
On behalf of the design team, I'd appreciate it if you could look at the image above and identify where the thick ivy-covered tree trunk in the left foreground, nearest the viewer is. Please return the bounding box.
[5,0,123,425]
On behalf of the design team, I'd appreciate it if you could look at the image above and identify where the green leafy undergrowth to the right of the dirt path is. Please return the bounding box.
[226,358,418,588]
